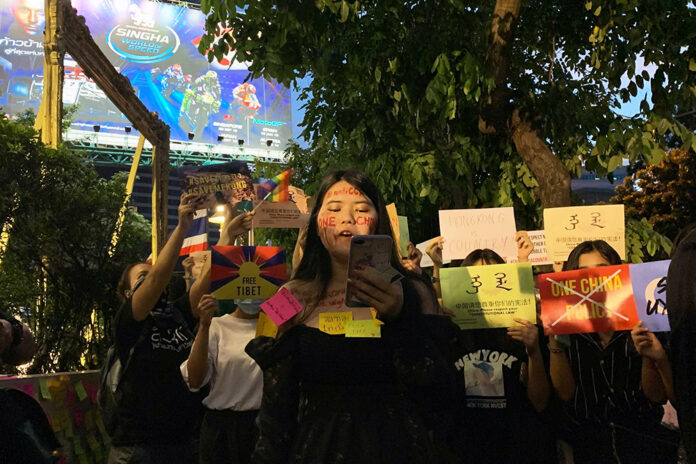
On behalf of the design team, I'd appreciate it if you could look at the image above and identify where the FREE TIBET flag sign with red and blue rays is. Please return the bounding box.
[210,246,287,300]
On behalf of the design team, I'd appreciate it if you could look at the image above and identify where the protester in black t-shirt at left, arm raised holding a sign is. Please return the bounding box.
[108,194,253,464]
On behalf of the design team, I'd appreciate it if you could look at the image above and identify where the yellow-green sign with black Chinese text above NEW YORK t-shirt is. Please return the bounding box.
[440,263,536,329]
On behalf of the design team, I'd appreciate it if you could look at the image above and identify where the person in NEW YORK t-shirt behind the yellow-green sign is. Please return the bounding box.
[450,247,555,464]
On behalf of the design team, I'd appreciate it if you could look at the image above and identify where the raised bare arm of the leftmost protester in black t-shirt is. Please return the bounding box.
[131,194,201,321]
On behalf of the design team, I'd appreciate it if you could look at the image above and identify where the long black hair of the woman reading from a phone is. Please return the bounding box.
[290,168,432,302]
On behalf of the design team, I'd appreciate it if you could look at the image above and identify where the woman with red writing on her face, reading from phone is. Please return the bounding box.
[246,169,454,464]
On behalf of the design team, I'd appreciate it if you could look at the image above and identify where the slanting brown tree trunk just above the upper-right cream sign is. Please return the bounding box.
[509,110,570,208]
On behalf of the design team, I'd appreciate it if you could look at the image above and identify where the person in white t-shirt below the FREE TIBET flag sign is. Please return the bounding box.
[181,295,264,464]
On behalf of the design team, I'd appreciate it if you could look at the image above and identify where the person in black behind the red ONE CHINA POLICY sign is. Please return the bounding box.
[549,240,677,464]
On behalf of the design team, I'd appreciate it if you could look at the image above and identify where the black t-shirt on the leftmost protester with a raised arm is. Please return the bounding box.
[112,294,199,446]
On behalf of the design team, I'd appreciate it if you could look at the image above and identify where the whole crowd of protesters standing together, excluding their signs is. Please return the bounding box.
[0,169,696,464]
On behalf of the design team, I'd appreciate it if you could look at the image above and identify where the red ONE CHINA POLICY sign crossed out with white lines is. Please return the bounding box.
[539,264,638,335]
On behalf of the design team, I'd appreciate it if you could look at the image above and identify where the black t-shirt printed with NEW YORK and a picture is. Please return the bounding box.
[450,328,553,463]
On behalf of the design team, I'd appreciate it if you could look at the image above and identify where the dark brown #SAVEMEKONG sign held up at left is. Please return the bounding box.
[179,161,256,211]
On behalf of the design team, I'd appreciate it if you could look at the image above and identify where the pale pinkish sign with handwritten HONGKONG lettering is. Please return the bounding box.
[439,208,517,260]
